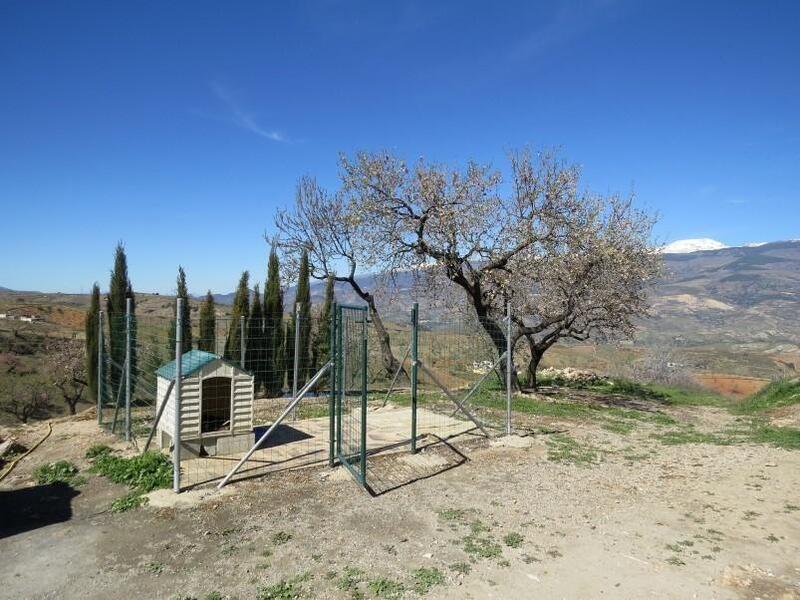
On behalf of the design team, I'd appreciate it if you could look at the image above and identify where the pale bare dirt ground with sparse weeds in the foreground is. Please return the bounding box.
[0,398,800,599]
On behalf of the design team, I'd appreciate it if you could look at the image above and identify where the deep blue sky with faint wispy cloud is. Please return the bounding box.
[0,0,800,293]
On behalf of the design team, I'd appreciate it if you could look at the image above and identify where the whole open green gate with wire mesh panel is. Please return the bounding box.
[334,305,367,487]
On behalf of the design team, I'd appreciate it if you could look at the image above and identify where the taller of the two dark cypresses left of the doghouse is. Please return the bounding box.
[106,242,136,404]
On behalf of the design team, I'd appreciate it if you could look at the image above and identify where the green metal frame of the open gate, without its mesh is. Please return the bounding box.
[334,304,368,489]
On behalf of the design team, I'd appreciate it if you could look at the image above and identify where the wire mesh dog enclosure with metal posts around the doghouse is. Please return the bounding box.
[98,300,506,493]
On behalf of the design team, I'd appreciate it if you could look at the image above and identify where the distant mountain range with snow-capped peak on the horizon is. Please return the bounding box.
[0,239,800,354]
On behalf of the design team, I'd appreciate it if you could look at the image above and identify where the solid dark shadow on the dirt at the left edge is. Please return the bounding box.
[0,482,80,539]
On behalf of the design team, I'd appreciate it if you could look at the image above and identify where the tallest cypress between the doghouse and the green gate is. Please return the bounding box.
[264,244,286,398]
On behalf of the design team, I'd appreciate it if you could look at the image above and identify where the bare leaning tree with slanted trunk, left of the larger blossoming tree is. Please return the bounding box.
[275,177,400,376]
